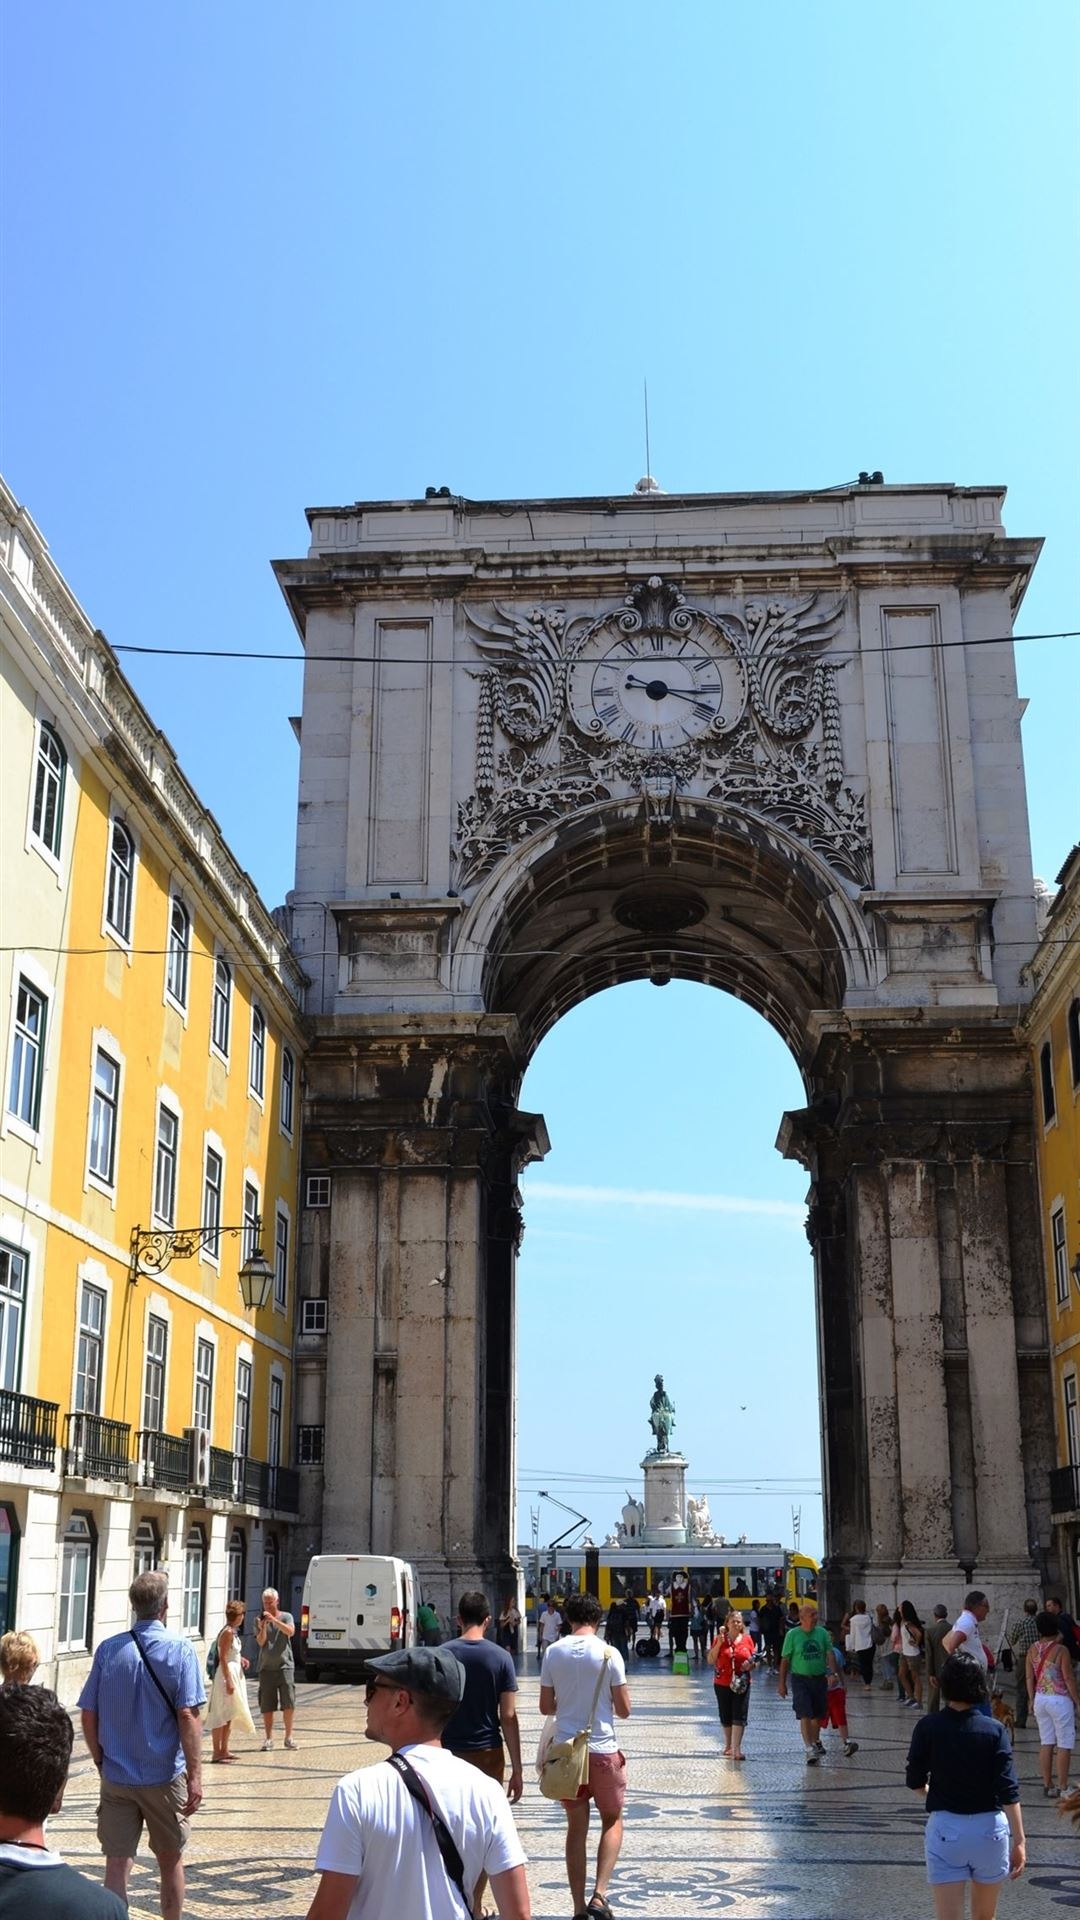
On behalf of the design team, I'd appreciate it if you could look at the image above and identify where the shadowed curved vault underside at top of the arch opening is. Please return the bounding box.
[455,804,876,1068]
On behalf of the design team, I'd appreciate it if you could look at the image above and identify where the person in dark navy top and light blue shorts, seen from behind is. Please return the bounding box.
[907,1653,1024,1920]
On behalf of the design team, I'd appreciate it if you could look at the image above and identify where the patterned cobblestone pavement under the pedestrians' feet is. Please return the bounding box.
[50,1657,1080,1920]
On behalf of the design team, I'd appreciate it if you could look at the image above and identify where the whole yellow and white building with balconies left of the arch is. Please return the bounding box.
[0,476,309,1699]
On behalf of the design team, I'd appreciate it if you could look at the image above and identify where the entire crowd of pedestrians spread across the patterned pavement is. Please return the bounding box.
[0,1572,1080,1920]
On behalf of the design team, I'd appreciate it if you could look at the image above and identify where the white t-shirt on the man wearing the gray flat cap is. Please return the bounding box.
[315,1745,525,1920]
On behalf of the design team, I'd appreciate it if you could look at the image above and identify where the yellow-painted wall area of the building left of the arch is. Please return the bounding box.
[37,744,302,1463]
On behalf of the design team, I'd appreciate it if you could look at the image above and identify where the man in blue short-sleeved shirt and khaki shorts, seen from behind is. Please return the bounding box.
[79,1572,206,1920]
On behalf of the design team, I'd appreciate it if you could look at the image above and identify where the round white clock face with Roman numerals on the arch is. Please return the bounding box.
[569,628,746,753]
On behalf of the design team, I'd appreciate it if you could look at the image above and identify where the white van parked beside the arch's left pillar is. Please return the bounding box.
[300,1553,419,1680]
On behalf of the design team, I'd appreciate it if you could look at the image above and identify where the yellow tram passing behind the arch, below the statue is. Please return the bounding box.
[521,1540,819,1611]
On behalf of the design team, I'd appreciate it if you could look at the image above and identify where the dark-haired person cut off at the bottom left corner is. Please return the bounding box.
[0,1686,127,1920]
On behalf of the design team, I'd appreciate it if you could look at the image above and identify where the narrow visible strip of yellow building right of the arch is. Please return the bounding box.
[1028,847,1080,1609]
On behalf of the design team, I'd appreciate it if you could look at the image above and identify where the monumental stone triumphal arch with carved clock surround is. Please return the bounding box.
[277,484,1051,1605]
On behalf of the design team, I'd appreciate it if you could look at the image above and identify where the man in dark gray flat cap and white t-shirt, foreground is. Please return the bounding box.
[307,1647,530,1920]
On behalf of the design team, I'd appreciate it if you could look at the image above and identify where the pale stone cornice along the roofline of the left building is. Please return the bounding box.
[0,480,306,1008]
